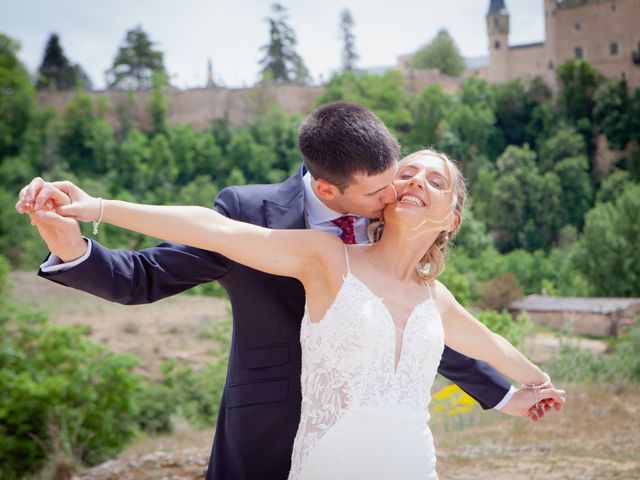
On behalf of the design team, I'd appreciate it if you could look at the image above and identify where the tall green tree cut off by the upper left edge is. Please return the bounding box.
[0,33,35,160]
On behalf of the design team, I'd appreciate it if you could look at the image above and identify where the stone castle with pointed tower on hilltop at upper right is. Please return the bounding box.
[478,0,640,91]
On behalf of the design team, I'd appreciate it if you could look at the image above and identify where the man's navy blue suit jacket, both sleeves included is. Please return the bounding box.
[39,169,510,480]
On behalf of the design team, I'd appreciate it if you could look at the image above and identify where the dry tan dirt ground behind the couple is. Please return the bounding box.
[12,273,640,480]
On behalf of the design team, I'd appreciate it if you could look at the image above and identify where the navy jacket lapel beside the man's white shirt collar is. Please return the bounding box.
[263,167,306,229]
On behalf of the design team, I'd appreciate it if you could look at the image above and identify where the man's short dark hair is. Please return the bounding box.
[298,102,400,192]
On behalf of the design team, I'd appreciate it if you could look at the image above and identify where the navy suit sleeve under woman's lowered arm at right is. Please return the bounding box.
[438,346,511,410]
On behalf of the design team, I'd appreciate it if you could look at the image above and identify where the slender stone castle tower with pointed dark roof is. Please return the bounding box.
[487,0,509,82]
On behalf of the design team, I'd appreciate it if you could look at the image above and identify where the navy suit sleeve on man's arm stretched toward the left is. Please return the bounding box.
[38,188,240,305]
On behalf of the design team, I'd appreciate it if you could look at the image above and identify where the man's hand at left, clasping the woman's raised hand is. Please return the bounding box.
[16,177,88,263]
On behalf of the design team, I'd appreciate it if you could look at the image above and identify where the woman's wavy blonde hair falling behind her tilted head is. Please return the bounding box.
[367,149,467,282]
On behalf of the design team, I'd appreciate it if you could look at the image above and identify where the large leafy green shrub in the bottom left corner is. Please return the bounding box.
[0,304,140,479]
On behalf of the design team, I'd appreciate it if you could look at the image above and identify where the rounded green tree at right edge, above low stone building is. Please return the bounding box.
[574,183,640,297]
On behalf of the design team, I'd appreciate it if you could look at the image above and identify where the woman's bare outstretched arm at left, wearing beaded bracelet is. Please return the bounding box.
[26,182,342,280]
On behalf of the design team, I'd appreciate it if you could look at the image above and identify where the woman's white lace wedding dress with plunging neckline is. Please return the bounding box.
[289,249,444,480]
